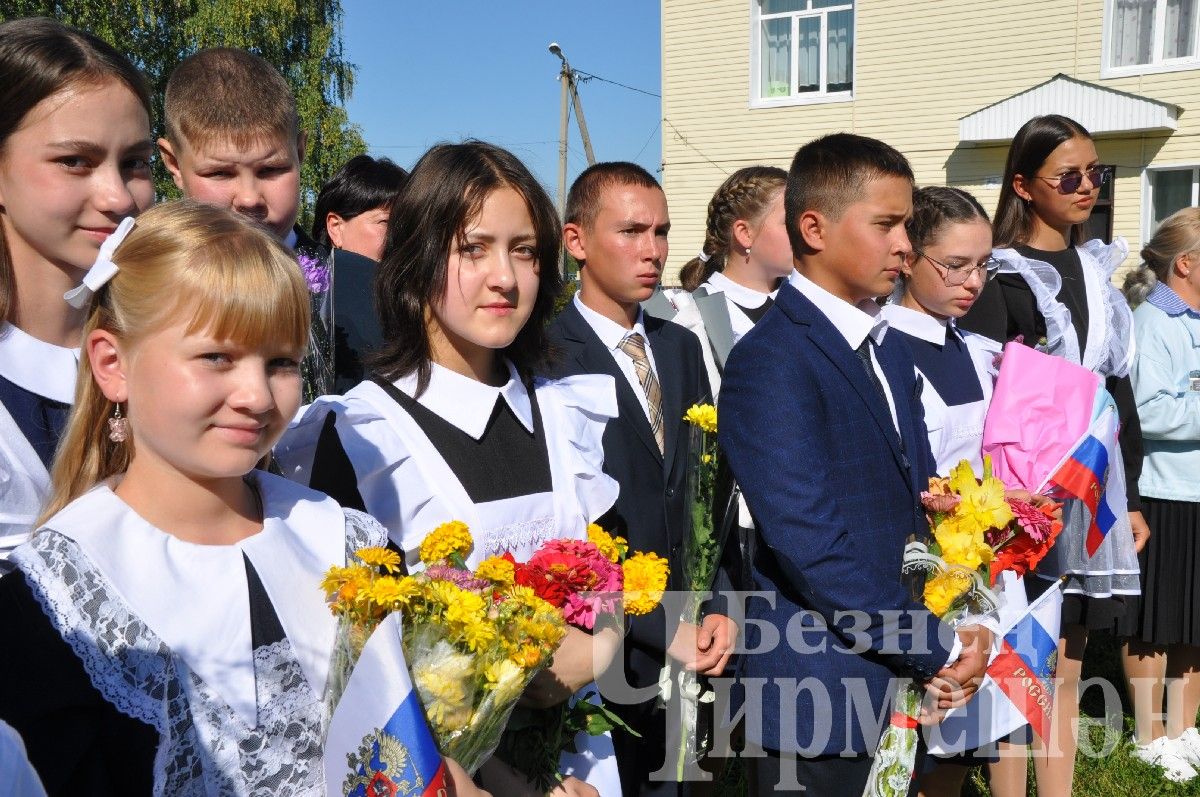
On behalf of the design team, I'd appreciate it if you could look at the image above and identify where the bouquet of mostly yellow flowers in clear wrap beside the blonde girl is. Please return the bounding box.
[322,521,566,773]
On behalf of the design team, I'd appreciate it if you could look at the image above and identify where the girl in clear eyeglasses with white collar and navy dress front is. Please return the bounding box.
[883,186,1000,475]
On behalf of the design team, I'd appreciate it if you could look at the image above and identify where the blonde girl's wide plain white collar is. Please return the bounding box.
[43,471,346,727]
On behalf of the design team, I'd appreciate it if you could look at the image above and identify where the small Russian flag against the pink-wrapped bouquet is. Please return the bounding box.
[1046,391,1124,556]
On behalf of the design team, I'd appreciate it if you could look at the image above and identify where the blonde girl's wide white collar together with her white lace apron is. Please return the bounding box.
[12,472,386,793]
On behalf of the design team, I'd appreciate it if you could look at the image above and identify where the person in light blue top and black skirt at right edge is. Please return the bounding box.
[1117,208,1200,780]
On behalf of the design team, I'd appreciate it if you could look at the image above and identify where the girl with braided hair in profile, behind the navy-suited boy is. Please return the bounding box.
[646,166,792,397]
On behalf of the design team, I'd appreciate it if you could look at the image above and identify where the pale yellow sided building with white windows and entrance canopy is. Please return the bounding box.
[661,0,1200,283]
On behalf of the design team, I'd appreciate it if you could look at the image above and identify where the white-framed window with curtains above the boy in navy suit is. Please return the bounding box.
[752,0,854,100]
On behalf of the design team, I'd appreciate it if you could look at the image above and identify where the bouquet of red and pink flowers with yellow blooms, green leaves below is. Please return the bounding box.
[498,523,667,791]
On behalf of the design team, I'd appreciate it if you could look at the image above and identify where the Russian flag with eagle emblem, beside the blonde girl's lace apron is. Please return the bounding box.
[324,612,448,797]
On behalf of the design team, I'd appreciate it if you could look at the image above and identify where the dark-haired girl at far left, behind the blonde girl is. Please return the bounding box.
[0,18,154,573]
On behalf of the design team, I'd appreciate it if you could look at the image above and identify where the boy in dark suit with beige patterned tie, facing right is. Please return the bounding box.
[550,162,737,797]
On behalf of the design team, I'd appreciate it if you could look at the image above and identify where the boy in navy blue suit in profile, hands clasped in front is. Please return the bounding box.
[720,133,991,797]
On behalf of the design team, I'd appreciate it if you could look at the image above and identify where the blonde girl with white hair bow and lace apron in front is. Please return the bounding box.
[0,202,469,795]
